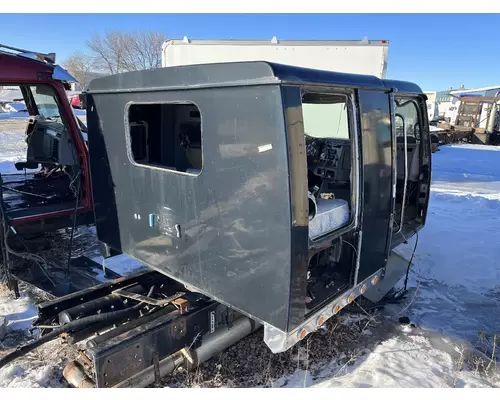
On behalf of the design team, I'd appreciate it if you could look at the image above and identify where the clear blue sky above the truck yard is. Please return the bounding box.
[0,14,500,90]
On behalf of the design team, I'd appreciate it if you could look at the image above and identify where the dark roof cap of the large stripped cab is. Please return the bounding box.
[87,61,423,94]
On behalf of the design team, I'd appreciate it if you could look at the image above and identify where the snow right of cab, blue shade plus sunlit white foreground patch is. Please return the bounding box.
[264,145,500,387]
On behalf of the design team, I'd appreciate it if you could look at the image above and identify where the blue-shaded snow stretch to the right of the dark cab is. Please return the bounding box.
[388,145,500,360]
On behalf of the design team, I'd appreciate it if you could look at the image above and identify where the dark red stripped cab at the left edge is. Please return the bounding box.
[0,44,93,236]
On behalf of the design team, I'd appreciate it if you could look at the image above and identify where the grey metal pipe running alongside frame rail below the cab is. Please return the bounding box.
[114,317,261,388]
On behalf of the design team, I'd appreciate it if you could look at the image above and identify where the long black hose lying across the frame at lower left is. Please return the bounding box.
[0,303,141,368]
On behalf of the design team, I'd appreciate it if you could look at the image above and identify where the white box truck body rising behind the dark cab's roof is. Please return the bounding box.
[162,37,389,78]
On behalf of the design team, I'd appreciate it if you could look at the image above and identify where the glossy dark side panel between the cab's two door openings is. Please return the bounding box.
[358,90,393,282]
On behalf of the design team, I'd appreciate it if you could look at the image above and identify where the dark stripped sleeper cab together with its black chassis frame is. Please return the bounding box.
[0,47,431,387]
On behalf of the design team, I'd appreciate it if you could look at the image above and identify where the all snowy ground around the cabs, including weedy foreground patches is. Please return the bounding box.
[0,120,500,387]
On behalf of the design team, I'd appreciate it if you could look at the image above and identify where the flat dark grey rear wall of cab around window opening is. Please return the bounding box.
[88,85,291,331]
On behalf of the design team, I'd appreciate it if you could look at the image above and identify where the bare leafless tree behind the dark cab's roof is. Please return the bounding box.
[87,31,166,74]
